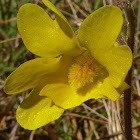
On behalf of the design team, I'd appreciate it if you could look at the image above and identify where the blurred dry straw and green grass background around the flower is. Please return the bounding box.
[0,0,140,140]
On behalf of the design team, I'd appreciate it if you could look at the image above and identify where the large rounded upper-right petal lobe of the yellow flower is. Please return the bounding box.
[78,5,123,60]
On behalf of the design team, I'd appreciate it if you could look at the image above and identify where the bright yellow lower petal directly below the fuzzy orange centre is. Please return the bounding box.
[39,84,103,109]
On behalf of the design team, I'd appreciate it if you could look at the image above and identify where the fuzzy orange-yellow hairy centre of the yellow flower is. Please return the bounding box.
[68,51,101,89]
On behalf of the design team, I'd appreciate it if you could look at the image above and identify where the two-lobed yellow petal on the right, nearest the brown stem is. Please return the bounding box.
[78,6,132,88]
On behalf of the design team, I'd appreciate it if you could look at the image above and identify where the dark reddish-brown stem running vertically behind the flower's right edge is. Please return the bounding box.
[114,0,135,140]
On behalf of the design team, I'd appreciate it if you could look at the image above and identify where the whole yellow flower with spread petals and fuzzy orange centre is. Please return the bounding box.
[4,0,132,130]
